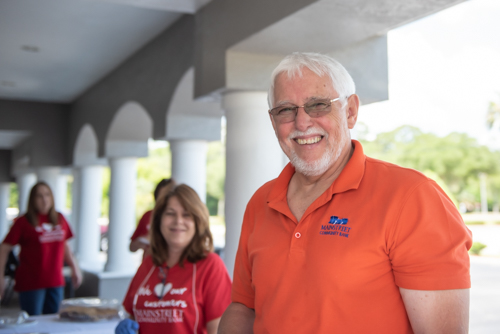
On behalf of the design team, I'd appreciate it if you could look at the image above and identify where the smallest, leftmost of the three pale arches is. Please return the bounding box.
[73,123,104,166]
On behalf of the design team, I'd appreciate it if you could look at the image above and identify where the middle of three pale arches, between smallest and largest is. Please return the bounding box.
[105,101,153,157]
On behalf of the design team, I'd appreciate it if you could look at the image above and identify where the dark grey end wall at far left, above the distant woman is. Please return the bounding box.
[0,100,70,167]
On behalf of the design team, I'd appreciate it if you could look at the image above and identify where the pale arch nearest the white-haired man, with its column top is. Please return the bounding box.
[166,67,223,140]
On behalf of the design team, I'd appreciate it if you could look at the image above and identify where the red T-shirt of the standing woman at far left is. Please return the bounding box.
[3,214,73,291]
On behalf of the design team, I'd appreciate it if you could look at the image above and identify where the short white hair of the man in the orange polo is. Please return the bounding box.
[268,52,356,109]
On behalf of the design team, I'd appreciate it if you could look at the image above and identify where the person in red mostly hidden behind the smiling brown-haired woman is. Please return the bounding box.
[129,179,175,257]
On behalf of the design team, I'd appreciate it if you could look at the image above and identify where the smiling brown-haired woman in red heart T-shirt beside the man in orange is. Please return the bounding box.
[115,184,231,334]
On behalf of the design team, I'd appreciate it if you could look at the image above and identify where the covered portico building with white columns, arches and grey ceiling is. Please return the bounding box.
[0,0,463,296]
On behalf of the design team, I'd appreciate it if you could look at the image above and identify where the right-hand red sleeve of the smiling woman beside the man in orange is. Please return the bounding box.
[203,254,231,322]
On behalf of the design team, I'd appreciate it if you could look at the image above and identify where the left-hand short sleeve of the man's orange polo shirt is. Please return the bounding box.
[231,207,255,309]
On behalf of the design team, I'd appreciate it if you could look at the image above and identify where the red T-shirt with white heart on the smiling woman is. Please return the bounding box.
[123,253,231,334]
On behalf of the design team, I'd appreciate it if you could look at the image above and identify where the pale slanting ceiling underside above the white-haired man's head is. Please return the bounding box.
[230,0,464,55]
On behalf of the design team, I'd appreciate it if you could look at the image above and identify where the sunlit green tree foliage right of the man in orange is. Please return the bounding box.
[361,126,500,209]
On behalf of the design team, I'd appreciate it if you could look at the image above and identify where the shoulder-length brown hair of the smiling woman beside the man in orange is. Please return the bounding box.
[149,184,214,267]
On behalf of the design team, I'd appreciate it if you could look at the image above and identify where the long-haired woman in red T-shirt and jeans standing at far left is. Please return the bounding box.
[0,182,82,315]
